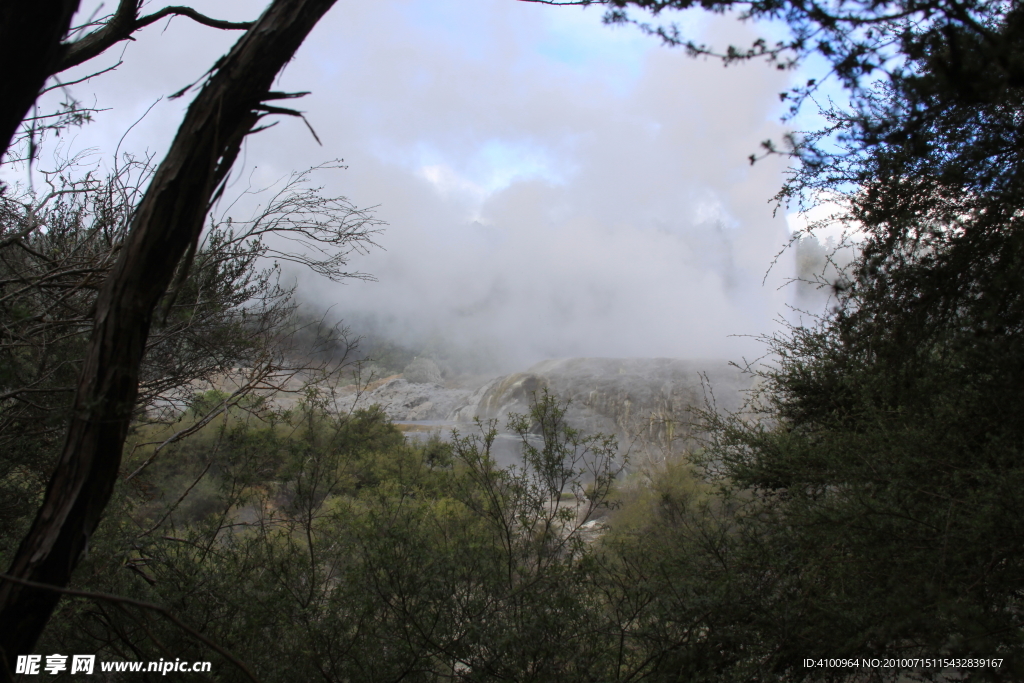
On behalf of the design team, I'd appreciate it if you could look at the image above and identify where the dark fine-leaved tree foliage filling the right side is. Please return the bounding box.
[618,3,1024,680]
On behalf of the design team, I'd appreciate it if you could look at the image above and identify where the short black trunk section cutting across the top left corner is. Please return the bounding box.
[0,0,78,159]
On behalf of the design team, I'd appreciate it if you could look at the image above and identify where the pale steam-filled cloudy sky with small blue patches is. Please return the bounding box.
[29,0,806,369]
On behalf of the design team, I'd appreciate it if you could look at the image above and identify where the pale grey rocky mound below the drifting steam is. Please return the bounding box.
[359,358,751,462]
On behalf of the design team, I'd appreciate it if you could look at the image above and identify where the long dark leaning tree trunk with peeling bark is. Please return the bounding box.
[0,0,334,663]
